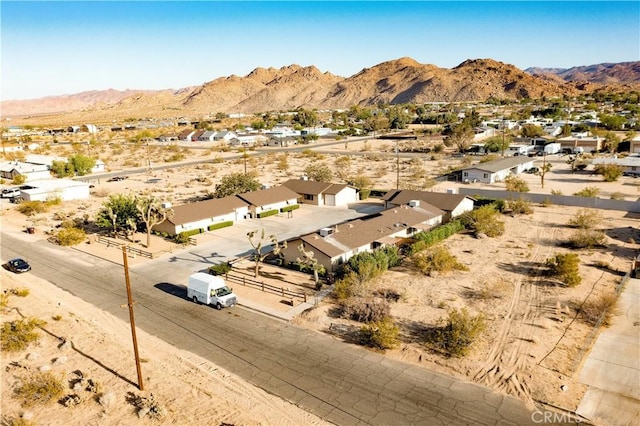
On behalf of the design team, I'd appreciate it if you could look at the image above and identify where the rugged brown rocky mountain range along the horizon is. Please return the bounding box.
[1,57,640,122]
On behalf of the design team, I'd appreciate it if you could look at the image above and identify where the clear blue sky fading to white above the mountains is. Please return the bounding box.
[0,0,640,100]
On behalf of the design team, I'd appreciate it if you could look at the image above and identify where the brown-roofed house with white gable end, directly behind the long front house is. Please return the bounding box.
[382,189,474,223]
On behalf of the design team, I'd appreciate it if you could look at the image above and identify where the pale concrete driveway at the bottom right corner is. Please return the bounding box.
[577,278,640,426]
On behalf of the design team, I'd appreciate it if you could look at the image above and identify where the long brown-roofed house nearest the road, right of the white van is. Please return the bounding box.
[281,205,443,273]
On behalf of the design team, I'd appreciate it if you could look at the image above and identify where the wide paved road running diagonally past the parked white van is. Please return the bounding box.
[2,233,535,425]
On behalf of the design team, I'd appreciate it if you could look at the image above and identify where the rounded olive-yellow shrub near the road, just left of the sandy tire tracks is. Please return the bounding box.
[427,308,486,357]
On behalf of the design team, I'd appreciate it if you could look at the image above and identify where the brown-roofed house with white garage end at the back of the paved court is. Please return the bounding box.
[282,178,358,206]
